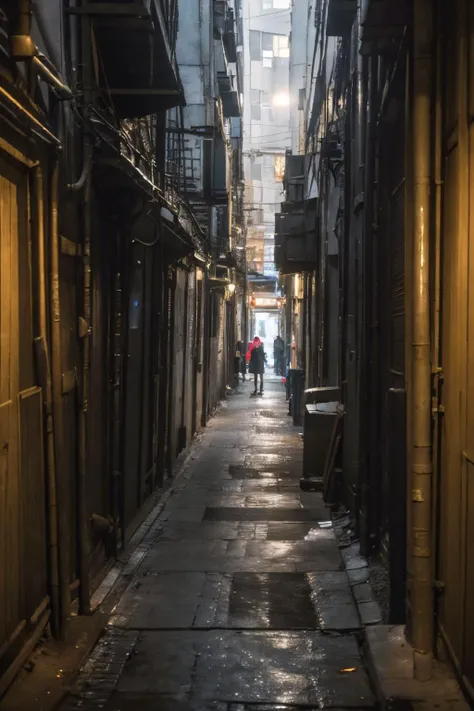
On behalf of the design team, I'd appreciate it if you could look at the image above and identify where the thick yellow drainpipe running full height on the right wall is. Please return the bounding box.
[410,0,433,681]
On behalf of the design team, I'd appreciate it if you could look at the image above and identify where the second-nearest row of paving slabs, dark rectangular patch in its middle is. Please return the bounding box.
[110,568,360,631]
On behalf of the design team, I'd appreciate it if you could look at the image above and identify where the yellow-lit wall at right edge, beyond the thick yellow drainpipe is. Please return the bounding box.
[433,0,474,694]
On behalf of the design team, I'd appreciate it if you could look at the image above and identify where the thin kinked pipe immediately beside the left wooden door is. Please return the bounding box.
[34,166,60,636]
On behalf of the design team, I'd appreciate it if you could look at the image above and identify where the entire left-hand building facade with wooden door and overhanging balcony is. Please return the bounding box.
[0,0,246,694]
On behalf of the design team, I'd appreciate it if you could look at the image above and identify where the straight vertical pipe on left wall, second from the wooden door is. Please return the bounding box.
[49,160,70,637]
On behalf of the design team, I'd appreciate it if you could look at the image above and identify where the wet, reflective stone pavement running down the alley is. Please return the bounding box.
[61,379,375,711]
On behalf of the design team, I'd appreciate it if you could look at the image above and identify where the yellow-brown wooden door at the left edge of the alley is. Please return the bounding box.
[0,156,49,680]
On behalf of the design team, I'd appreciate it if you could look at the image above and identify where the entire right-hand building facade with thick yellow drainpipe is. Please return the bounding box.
[275,0,474,695]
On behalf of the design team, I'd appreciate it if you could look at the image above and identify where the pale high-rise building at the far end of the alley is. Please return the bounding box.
[243,0,291,276]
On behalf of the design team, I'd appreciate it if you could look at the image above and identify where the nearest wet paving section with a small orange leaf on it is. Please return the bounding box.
[117,630,374,708]
